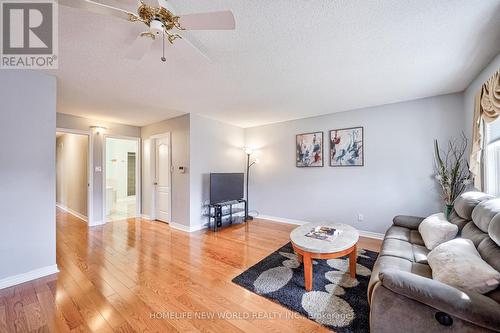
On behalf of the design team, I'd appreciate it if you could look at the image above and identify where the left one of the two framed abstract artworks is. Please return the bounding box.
[295,132,323,168]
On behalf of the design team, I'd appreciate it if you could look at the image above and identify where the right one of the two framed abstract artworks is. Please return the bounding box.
[330,127,365,167]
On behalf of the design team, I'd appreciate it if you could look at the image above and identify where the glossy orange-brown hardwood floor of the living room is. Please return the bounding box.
[0,210,380,333]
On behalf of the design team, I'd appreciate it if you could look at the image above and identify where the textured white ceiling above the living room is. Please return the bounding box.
[49,0,500,127]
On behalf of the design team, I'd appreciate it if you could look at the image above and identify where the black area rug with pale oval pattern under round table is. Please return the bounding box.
[233,243,377,333]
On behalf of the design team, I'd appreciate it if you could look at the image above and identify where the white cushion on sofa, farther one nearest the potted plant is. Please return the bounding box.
[418,213,458,250]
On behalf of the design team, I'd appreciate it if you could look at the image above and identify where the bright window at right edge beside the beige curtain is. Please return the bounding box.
[484,119,500,196]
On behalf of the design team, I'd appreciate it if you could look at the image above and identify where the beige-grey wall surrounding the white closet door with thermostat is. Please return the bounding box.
[141,114,190,226]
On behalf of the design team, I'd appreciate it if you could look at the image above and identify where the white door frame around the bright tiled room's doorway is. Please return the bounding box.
[102,134,142,224]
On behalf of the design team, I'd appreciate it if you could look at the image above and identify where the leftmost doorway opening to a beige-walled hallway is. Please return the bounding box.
[56,129,92,223]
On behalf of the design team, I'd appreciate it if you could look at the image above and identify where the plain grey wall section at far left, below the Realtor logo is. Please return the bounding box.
[0,70,56,280]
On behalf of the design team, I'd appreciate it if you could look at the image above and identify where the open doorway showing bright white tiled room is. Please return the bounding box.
[104,136,140,221]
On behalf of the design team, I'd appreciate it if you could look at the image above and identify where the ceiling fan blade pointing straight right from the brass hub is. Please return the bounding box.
[179,10,236,30]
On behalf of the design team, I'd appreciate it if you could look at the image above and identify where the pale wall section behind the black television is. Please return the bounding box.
[189,114,245,229]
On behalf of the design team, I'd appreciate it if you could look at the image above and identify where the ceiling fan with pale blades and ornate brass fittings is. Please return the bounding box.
[58,0,236,61]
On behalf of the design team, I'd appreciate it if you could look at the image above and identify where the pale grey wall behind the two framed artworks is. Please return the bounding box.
[246,94,464,233]
